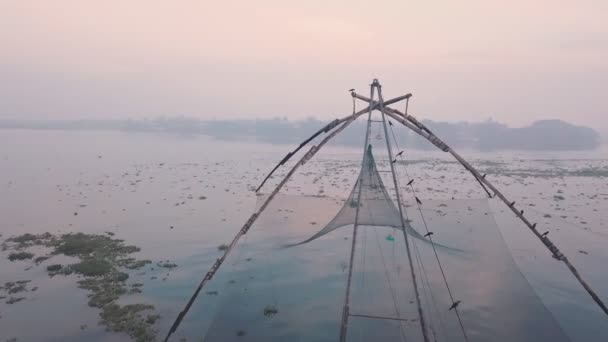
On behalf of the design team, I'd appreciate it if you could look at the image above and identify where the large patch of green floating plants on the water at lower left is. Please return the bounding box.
[0,233,162,342]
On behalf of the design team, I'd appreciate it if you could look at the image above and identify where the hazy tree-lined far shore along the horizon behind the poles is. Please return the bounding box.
[0,117,601,151]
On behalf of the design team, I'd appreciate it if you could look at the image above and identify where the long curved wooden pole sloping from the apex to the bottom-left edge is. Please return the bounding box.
[164,112,360,342]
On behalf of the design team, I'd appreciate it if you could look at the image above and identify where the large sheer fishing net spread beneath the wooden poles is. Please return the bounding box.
[171,118,588,342]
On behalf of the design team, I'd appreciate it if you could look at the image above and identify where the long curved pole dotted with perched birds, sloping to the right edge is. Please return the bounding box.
[352,93,608,315]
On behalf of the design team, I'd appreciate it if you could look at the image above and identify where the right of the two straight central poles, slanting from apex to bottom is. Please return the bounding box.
[372,81,429,342]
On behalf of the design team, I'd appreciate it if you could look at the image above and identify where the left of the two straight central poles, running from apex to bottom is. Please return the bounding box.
[340,82,375,342]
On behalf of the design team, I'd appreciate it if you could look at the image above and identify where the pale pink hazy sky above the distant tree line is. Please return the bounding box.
[0,0,608,130]
